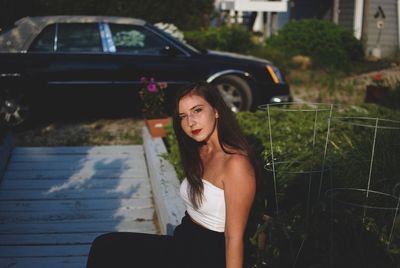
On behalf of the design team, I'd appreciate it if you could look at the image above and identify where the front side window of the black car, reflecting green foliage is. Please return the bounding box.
[109,24,169,55]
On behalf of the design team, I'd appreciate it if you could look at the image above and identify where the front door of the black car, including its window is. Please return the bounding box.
[108,23,200,113]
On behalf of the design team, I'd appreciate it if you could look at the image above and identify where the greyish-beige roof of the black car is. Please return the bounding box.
[0,15,146,52]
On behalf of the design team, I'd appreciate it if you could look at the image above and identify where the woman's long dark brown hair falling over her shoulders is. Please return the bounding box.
[173,81,258,208]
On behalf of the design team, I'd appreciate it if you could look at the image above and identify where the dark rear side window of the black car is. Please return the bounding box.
[57,23,103,52]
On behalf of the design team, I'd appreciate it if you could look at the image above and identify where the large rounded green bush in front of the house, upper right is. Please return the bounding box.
[267,19,364,70]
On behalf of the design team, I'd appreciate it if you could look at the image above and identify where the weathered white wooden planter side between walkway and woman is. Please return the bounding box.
[142,127,186,235]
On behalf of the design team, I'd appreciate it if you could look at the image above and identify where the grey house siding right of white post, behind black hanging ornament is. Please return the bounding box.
[364,0,399,57]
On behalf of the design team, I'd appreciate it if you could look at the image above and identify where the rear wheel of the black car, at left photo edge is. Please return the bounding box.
[0,89,30,127]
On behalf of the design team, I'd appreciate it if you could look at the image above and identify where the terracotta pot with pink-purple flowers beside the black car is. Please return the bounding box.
[139,77,171,137]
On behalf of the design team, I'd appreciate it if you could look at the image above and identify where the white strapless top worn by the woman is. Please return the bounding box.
[180,179,225,232]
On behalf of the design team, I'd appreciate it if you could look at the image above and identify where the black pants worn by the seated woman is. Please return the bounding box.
[87,213,225,268]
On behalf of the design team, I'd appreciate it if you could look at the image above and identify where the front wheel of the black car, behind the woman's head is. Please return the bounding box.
[213,75,252,113]
